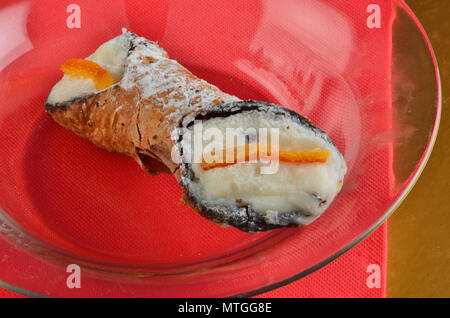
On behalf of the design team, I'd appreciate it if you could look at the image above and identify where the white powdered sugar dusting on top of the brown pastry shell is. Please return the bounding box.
[119,32,239,120]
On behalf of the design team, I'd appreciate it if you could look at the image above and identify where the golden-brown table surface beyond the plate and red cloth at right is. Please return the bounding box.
[387,0,450,297]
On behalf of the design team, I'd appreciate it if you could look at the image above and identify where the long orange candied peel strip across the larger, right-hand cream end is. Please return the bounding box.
[200,143,331,170]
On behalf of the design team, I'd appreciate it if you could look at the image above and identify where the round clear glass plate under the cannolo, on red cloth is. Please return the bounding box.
[0,0,441,297]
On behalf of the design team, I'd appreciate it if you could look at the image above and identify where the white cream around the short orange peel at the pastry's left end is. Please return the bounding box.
[47,33,130,104]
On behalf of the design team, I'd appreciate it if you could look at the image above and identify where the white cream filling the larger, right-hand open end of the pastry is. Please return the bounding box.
[183,111,346,224]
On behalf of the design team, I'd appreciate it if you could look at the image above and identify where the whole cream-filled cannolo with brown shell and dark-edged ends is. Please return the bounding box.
[45,31,346,232]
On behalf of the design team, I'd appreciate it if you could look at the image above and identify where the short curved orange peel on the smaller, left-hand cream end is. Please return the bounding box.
[60,59,114,90]
